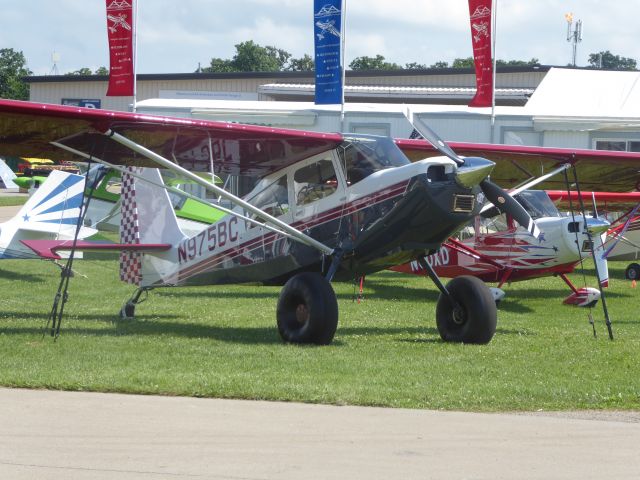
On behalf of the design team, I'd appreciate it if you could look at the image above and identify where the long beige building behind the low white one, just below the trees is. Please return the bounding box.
[24,66,550,111]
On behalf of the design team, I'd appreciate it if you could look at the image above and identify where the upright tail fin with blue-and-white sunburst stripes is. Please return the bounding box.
[9,170,96,239]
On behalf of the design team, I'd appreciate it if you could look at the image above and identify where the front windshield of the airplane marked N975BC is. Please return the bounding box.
[338,135,410,185]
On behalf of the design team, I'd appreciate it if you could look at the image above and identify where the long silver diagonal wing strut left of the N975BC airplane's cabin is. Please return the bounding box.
[103,129,334,255]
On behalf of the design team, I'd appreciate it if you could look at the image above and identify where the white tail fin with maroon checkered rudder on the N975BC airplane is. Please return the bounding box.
[120,167,185,286]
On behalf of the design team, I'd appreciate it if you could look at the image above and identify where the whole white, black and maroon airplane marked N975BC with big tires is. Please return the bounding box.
[0,100,538,344]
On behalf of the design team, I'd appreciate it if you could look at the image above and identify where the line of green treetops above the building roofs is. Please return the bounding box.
[0,40,637,100]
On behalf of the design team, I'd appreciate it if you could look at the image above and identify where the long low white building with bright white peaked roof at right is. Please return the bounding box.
[130,68,640,151]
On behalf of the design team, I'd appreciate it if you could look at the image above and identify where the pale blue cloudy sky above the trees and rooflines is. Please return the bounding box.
[0,0,640,75]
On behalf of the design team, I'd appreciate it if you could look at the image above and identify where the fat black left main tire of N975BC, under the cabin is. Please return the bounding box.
[277,272,338,345]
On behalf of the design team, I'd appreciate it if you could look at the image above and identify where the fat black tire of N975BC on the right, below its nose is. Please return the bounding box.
[436,276,498,343]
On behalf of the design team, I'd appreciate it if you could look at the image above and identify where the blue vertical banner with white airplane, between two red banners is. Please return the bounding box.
[313,0,342,105]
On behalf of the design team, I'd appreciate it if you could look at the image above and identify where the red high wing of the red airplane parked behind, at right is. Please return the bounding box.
[396,139,640,192]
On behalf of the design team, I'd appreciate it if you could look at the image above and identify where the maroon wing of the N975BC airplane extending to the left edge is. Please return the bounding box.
[0,100,342,176]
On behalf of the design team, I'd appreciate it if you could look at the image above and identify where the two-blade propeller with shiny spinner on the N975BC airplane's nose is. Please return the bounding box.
[405,110,540,238]
